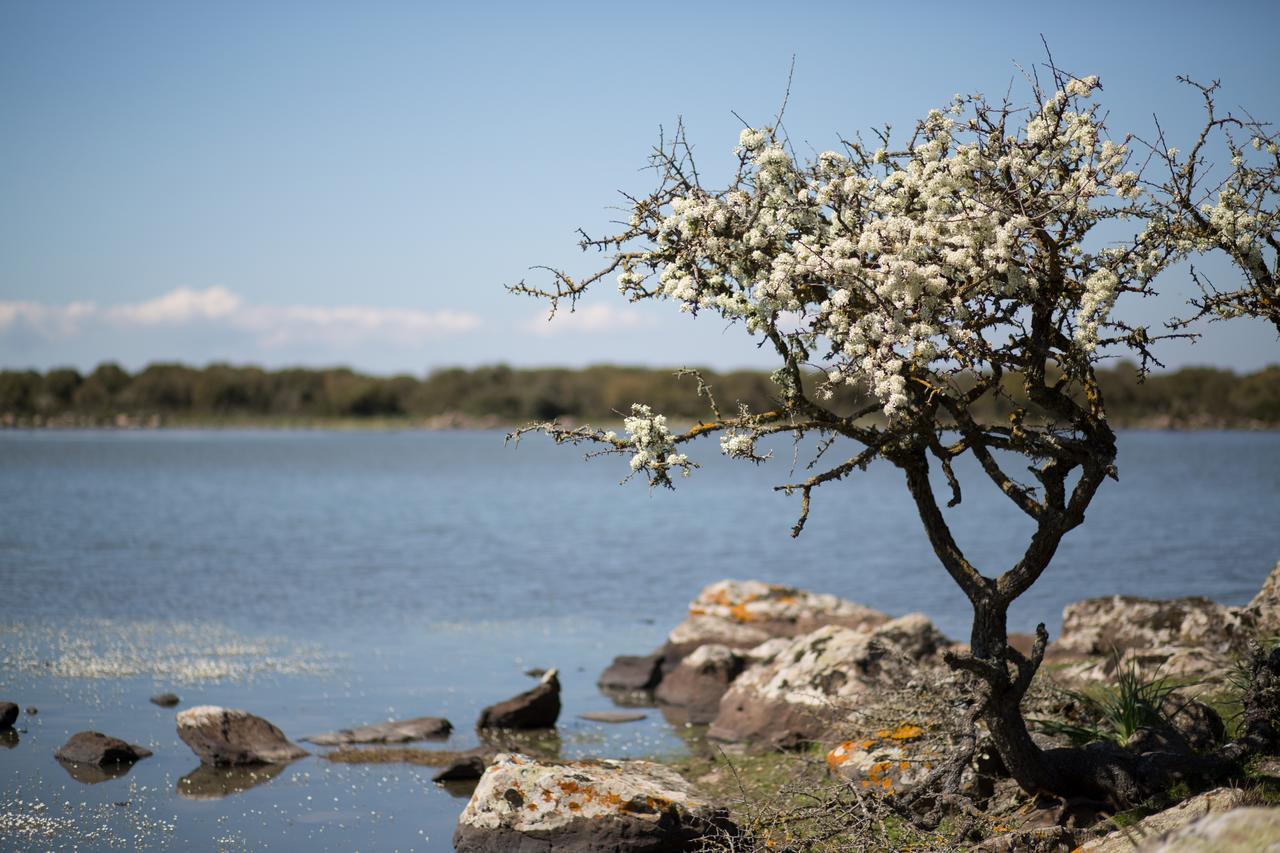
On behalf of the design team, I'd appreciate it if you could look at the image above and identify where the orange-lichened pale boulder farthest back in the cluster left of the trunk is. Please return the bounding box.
[662,580,888,671]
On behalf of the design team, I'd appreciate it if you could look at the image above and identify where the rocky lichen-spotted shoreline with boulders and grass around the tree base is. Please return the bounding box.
[0,565,1280,850]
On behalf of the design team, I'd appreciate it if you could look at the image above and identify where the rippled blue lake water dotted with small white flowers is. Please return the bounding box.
[0,432,1280,850]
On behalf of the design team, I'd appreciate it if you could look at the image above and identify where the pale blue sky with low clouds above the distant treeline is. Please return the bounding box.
[0,0,1280,373]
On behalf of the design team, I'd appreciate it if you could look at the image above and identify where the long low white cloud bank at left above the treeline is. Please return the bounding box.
[0,287,480,348]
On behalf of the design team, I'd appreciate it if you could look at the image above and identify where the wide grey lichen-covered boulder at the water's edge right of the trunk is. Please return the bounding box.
[1055,596,1256,654]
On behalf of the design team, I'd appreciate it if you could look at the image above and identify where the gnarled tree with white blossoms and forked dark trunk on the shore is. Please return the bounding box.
[511,69,1275,799]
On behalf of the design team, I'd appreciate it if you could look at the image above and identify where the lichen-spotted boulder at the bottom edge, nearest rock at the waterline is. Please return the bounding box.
[453,753,735,853]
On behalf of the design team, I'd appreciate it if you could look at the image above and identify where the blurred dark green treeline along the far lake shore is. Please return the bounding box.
[0,362,1280,428]
